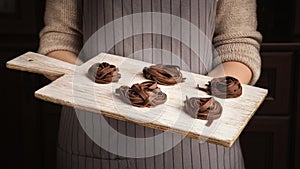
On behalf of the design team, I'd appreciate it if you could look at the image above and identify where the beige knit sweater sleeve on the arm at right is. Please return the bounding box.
[213,0,262,85]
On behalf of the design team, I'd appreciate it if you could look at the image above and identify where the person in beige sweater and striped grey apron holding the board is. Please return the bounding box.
[39,0,262,169]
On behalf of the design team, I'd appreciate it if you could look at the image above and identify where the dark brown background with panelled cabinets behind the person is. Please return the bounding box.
[0,0,300,169]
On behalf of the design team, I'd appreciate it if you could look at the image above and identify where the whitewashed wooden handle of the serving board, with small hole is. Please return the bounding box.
[6,52,76,76]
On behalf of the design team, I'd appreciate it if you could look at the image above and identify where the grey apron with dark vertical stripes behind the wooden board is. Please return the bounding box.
[57,0,244,169]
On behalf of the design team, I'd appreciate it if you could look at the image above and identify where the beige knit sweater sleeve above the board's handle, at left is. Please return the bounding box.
[38,0,82,55]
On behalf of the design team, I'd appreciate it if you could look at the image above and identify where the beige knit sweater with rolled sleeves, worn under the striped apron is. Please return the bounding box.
[38,0,262,84]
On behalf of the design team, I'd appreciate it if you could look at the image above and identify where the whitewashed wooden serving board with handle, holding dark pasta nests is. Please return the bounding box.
[7,52,267,147]
